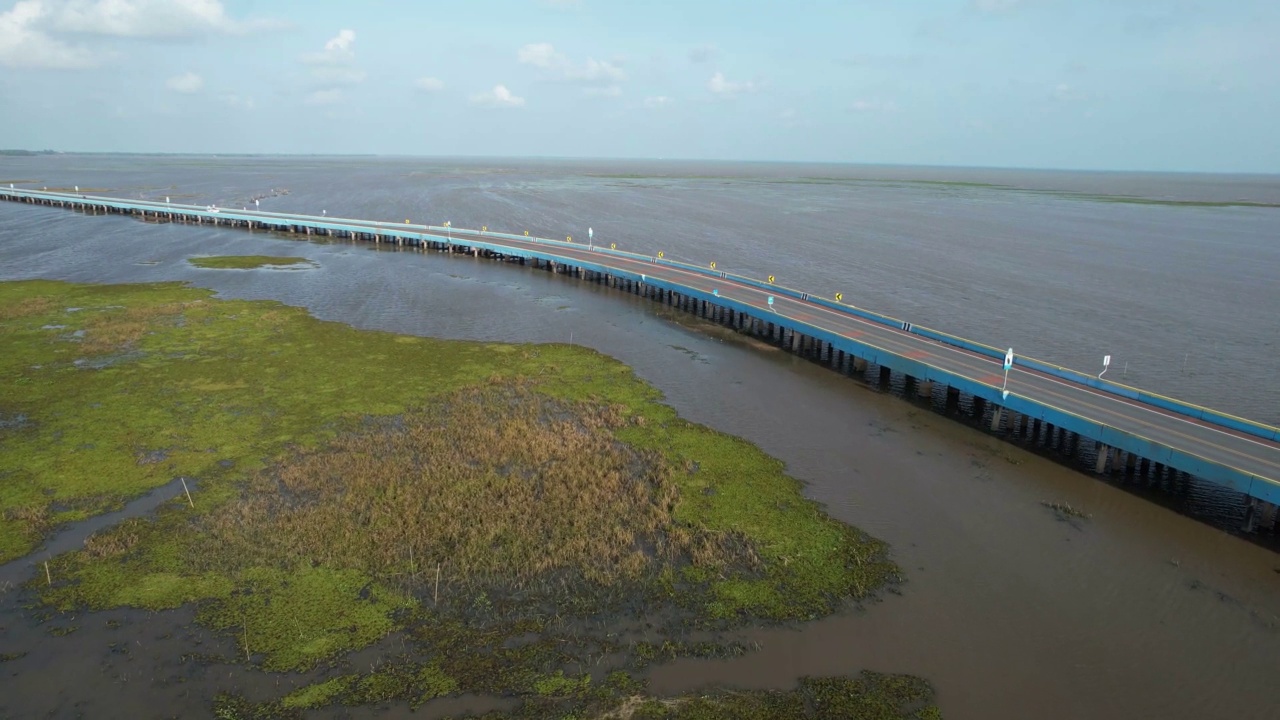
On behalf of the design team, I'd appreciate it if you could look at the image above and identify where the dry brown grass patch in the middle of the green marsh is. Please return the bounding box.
[206,384,750,588]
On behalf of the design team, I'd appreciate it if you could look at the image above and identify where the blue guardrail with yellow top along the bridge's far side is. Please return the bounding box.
[0,188,1280,441]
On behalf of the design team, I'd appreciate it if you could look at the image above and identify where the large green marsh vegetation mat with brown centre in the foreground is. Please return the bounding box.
[0,281,940,720]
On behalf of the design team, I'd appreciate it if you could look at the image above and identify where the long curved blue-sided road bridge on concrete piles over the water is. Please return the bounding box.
[0,187,1280,530]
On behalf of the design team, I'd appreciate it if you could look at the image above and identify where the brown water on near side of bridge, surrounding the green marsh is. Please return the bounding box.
[0,159,1280,719]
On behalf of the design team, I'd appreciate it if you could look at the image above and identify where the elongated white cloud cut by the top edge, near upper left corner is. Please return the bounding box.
[49,0,280,37]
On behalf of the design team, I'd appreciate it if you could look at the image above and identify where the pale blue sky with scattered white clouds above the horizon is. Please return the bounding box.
[0,0,1280,173]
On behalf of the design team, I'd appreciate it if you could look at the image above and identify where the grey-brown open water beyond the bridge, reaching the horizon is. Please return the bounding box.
[0,155,1280,424]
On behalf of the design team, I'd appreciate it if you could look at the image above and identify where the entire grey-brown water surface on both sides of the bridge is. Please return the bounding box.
[0,158,1280,720]
